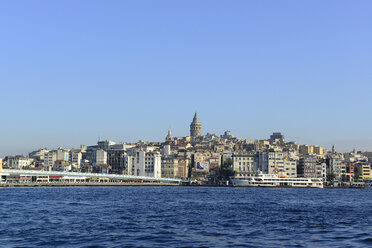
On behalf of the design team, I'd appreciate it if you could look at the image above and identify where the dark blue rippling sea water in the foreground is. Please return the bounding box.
[0,187,372,247]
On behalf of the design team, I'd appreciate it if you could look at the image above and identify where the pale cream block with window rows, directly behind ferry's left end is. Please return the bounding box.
[232,153,255,177]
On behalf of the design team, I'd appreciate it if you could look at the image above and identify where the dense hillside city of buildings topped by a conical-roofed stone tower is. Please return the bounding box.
[0,113,372,186]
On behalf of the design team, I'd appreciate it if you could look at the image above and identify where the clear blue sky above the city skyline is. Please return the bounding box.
[0,0,372,157]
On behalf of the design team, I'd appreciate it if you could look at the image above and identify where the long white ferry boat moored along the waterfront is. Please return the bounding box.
[230,174,323,188]
